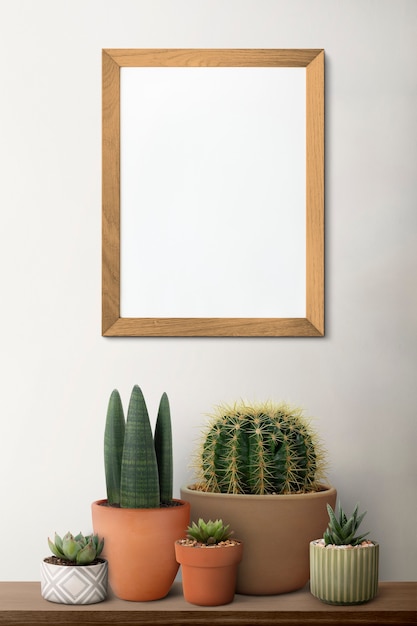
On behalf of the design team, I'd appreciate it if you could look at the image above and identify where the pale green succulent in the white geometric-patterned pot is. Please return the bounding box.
[48,532,104,565]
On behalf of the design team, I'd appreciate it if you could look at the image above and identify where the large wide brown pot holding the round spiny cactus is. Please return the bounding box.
[181,486,337,595]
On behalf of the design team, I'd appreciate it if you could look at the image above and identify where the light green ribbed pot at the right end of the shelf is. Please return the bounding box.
[310,540,379,605]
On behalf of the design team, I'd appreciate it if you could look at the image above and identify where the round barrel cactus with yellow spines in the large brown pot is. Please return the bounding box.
[195,402,326,494]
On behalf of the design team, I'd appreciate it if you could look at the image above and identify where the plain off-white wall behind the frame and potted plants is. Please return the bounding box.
[0,0,417,580]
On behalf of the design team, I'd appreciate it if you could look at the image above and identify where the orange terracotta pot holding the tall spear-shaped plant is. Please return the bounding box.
[92,500,190,602]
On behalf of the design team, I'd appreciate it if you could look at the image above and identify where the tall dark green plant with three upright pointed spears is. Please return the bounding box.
[104,385,173,508]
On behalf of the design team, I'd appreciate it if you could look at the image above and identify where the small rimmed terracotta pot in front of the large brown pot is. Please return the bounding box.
[175,541,243,606]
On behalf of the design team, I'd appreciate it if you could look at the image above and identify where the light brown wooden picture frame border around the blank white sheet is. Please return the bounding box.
[102,49,324,337]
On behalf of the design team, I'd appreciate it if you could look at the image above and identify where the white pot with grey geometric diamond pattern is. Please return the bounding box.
[41,559,108,604]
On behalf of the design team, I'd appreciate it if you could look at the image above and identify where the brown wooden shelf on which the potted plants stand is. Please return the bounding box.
[0,582,417,626]
